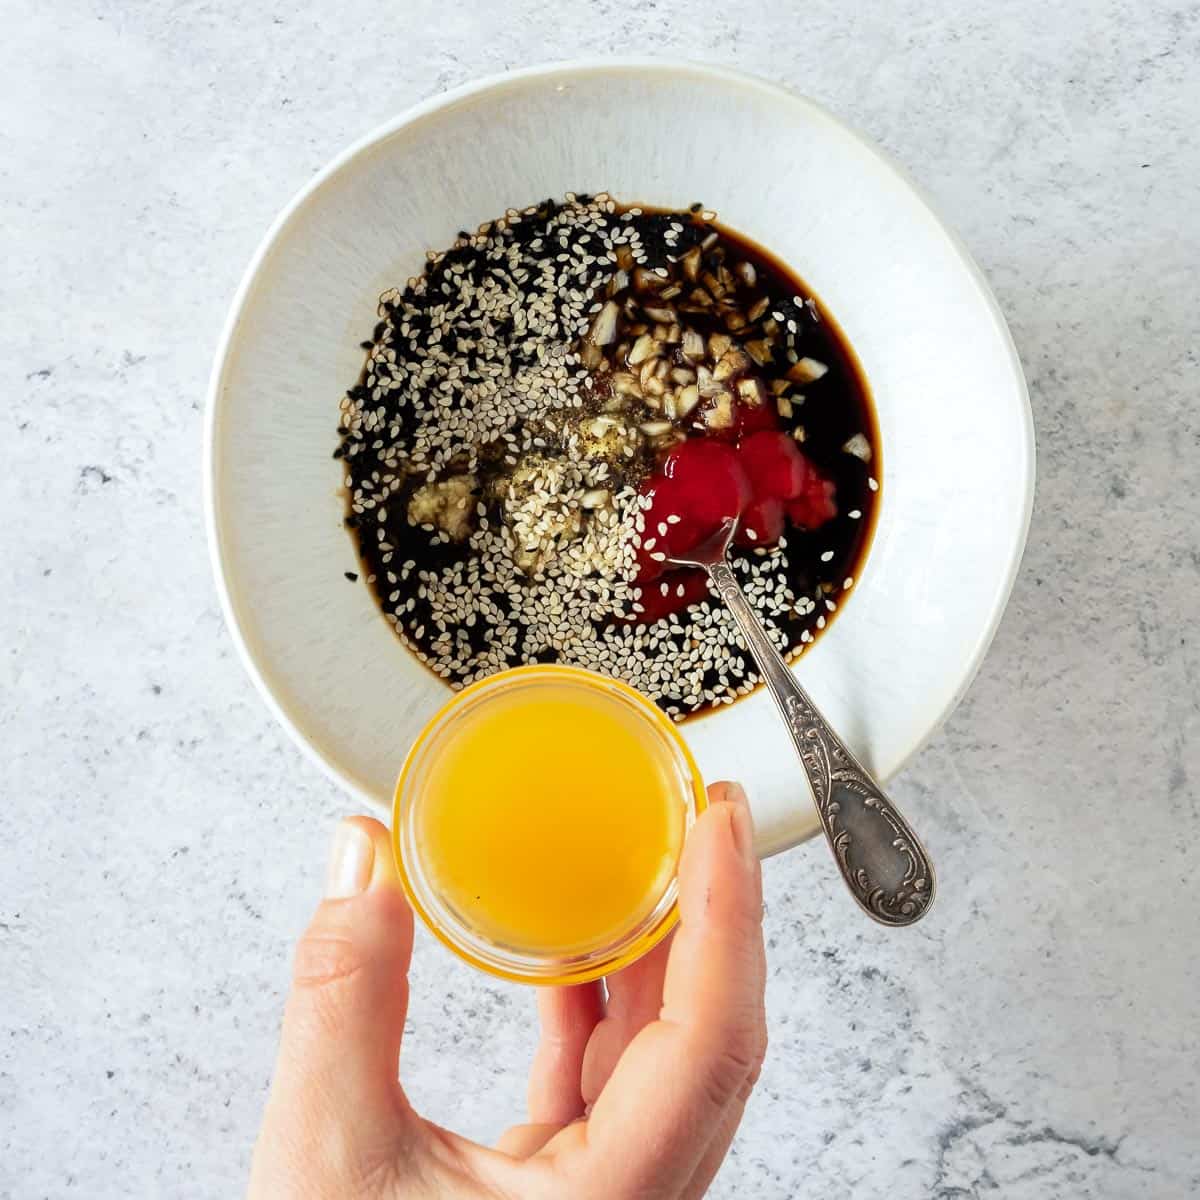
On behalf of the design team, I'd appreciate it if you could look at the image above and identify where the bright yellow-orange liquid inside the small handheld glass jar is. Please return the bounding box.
[414,680,691,955]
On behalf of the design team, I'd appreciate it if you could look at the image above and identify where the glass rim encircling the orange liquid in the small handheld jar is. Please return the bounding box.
[391,664,707,985]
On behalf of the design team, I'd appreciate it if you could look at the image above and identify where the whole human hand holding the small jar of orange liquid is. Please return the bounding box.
[250,784,767,1200]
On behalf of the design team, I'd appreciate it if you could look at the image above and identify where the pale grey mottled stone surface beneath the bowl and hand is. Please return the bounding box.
[0,0,1200,1200]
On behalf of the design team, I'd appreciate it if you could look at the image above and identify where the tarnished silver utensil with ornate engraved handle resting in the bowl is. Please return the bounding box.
[667,518,934,925]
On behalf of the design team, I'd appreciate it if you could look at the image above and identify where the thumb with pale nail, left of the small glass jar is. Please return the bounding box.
[261,817,413,1148]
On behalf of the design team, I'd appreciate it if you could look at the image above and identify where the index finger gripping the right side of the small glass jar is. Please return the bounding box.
[586,785,767,1193]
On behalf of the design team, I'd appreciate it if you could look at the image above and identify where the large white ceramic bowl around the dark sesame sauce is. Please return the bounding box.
[205,61,1033,854]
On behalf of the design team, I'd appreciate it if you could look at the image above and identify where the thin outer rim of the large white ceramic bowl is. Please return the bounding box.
[202,55,1036,835]
